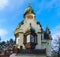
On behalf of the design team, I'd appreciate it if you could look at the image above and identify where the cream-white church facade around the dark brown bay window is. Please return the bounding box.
[14,5,51,56]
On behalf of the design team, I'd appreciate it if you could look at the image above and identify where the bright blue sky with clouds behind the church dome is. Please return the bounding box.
[0,0,60,41]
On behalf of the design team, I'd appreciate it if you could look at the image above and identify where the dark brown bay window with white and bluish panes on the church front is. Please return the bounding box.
[23,32,37,49]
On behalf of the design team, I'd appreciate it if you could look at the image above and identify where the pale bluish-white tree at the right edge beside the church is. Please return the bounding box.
[52,35,60,57]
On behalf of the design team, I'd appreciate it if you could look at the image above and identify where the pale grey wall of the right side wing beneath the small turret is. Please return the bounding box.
[41,40,51,56]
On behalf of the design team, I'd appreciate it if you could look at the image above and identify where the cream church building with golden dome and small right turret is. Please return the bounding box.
[14,5,52,57]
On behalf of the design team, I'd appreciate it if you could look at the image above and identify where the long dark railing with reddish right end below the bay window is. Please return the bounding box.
[17,49,46,54]
